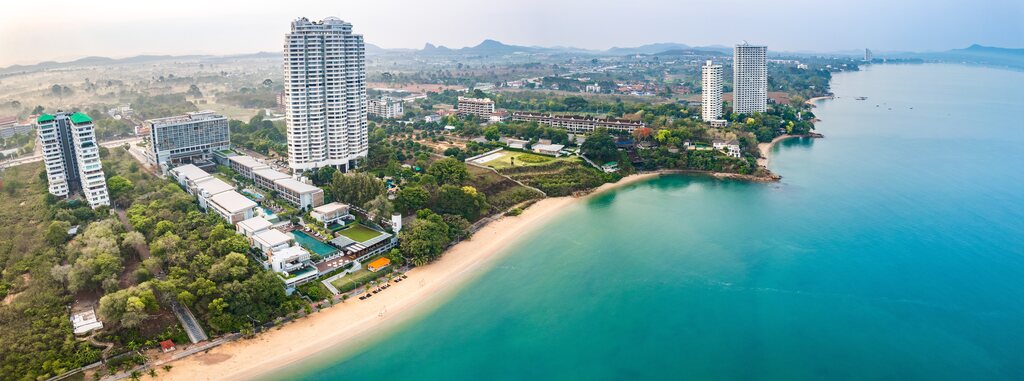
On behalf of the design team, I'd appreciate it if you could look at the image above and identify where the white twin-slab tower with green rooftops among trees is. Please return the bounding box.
[36,112,111,208]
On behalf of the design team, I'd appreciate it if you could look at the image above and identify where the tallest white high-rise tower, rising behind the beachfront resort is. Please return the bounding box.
[285,17,368,172]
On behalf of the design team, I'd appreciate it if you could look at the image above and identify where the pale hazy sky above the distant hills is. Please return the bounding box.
[0,0,1024,67]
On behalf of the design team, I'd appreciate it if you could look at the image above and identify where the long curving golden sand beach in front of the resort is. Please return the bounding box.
[161,173,659,381]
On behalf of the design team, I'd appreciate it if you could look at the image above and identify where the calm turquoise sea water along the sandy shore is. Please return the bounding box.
[271,66,1024,380]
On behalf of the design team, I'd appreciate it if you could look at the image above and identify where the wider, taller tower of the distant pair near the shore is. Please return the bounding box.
[732,42,768,114]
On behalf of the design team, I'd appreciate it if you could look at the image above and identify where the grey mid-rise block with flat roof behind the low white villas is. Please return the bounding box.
[144,111,231,170]
